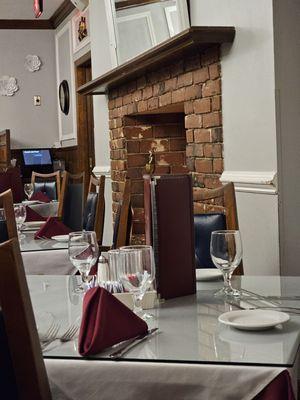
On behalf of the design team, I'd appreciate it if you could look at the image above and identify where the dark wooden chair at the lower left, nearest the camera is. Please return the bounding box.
[0,239,51,400]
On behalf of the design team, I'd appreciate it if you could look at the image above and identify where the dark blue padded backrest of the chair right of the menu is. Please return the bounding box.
[194,213,226,268]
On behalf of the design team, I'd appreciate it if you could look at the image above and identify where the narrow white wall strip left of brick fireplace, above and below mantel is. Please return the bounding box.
[90,0,113,245]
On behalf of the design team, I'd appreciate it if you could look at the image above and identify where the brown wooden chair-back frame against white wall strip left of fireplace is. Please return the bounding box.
[88,175,105,245]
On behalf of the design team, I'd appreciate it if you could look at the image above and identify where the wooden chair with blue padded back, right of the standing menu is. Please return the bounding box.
[193,182,243,275]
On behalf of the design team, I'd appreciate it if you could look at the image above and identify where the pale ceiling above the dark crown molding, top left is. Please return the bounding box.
[0,0,64,19]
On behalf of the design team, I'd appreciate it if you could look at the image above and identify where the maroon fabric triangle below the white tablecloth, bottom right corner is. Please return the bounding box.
[253,370,295,400]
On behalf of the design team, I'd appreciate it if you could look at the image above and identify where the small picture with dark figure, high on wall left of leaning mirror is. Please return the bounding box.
[72,7,90,53]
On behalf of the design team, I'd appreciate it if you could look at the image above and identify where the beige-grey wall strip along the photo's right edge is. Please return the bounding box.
[274,0,300,275]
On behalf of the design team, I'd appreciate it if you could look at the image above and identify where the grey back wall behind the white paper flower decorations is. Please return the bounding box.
[0,30,58,148]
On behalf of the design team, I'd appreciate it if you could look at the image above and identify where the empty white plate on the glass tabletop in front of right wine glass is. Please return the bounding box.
[218,310,290,331]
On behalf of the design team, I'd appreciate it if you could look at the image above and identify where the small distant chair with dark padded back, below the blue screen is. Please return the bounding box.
[31,171,60,201]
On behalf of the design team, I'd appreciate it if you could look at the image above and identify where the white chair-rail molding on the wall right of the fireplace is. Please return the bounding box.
[220,171,278,194]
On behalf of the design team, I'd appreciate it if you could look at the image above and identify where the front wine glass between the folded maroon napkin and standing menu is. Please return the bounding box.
[118,245,155,319]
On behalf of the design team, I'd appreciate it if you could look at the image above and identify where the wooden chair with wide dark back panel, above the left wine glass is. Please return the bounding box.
[58,171,85,231]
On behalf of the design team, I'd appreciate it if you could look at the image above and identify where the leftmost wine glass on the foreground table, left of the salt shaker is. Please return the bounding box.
[68,231,99,293]
